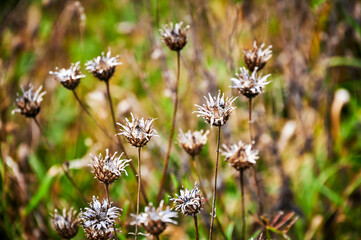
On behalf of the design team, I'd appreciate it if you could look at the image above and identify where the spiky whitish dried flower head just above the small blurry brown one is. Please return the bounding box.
[194,91,237,127]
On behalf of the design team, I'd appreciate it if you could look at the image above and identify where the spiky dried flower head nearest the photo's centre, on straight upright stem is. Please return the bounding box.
[117,113,157,148]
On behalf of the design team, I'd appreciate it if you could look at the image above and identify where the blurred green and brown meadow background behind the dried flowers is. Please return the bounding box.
[0,0,361,240]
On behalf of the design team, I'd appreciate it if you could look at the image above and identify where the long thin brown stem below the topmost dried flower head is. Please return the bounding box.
[157,51,180,203]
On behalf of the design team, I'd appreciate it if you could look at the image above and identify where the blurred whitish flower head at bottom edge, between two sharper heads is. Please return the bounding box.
[131,200,178,236]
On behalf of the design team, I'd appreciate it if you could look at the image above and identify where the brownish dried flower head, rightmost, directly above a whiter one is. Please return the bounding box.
[243,41,272,72]
